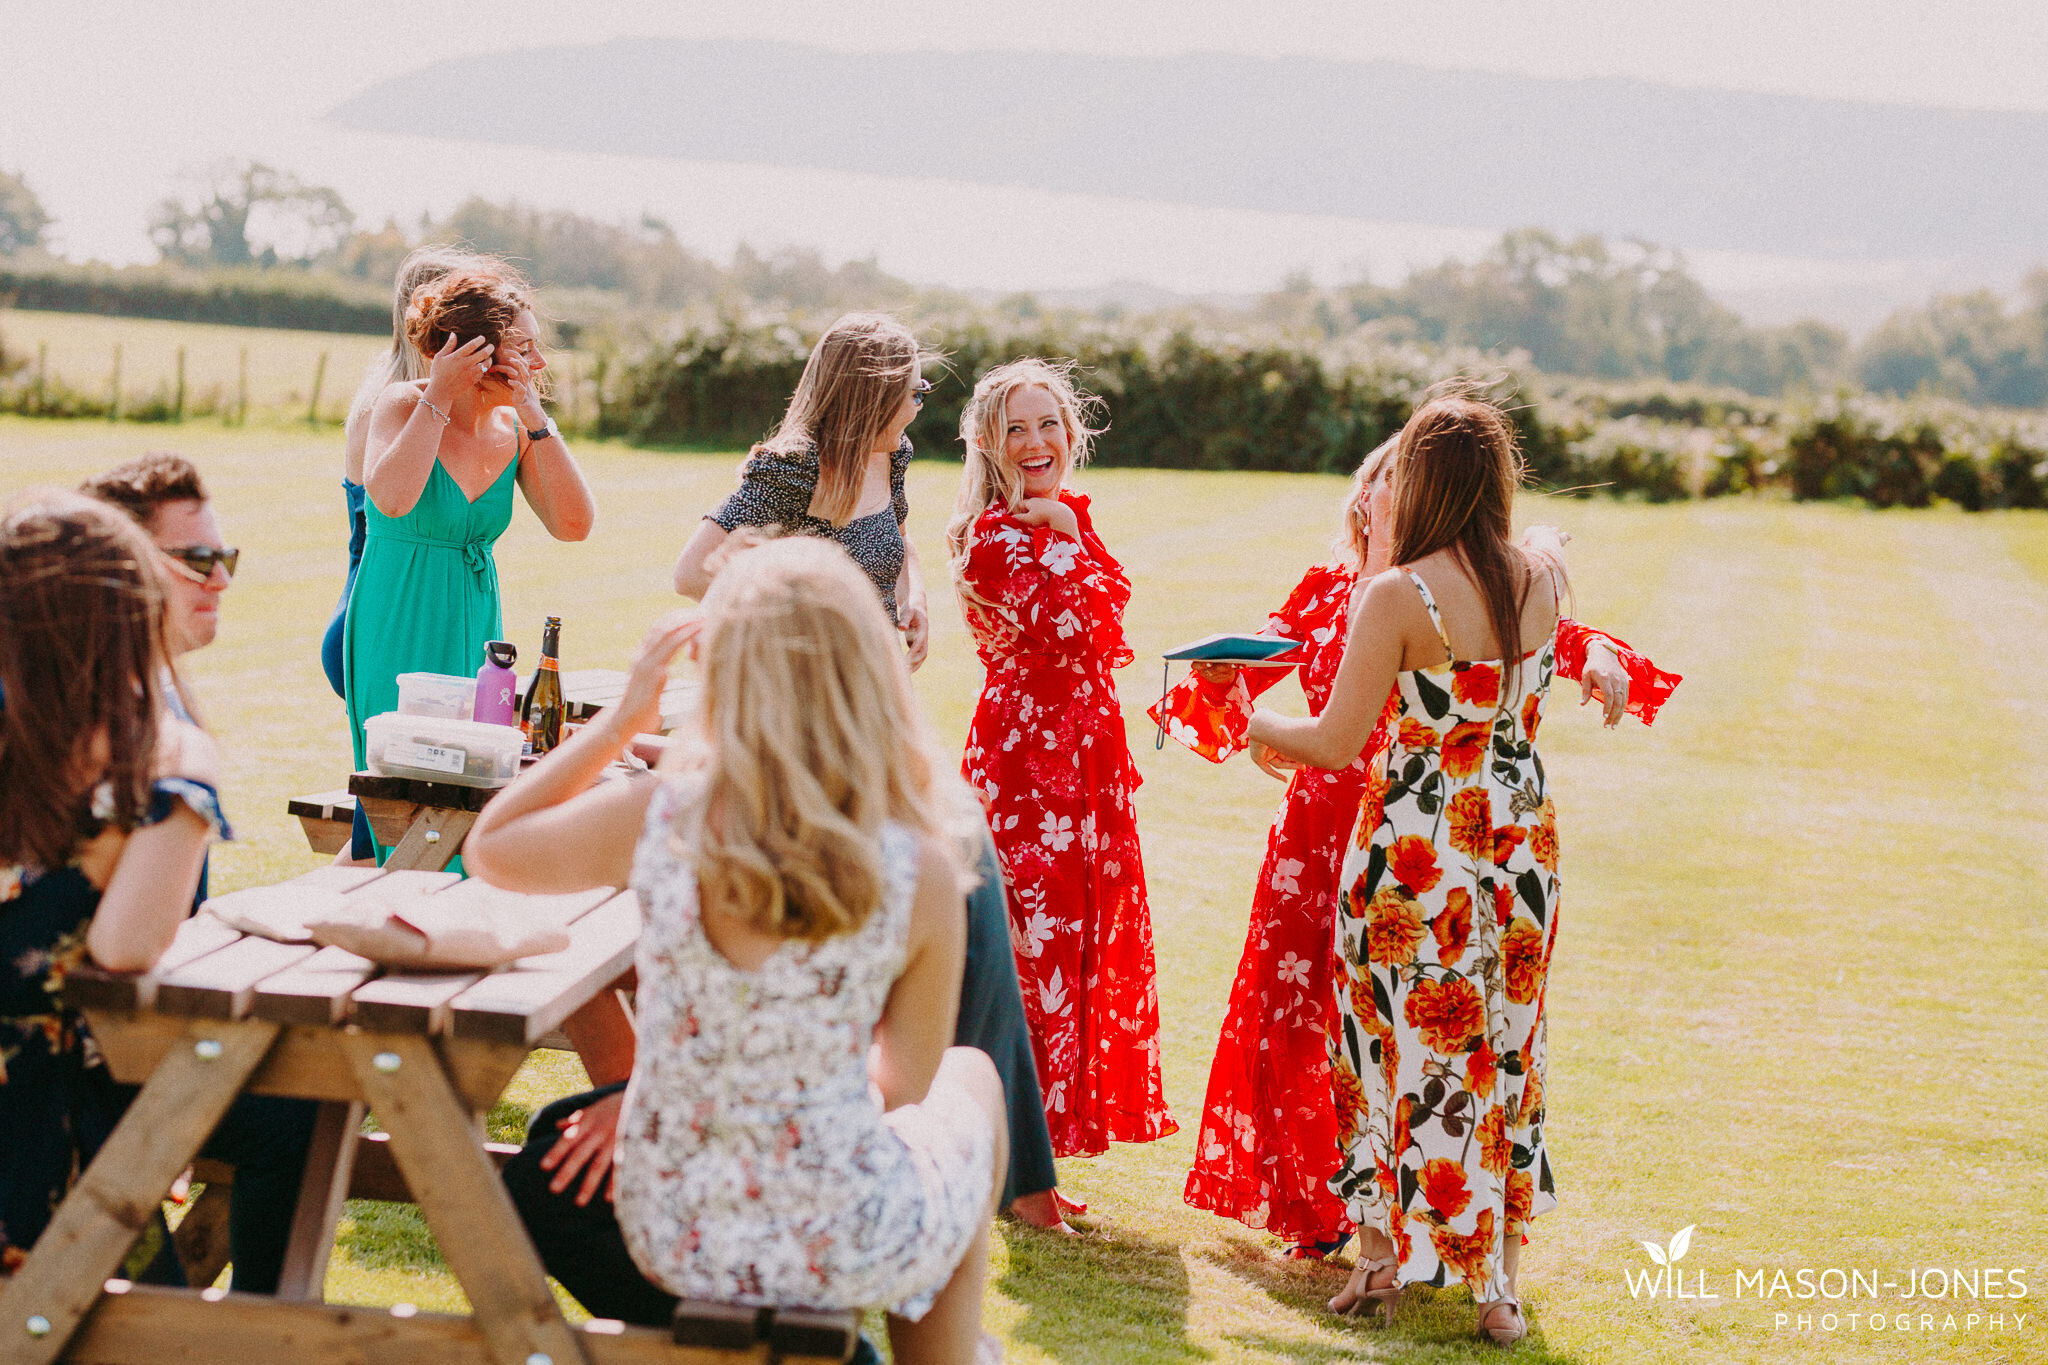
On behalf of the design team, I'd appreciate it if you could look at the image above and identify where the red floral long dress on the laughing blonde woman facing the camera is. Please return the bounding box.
[958,491,1178,1156]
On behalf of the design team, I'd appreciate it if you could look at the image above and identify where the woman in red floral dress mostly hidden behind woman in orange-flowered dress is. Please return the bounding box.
[1153,440,1675,1259]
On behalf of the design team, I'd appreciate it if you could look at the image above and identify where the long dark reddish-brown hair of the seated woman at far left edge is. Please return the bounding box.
[0,493,166,868]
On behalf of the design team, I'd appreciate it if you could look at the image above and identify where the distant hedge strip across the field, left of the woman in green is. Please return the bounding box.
[0,264,391,336]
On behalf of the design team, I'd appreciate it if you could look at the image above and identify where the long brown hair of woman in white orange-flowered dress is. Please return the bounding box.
[1389,395,1534,698]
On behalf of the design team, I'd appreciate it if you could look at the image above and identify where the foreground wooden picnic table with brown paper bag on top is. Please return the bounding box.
[0,868,850,1365]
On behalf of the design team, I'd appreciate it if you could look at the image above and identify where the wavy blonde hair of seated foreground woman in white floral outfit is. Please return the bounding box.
[664,536,979,943]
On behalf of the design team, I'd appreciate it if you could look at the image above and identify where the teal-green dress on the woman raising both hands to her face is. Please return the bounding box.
[342,440,524,864]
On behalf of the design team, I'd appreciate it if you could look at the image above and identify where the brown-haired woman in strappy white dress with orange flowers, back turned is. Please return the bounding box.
[1249,397,1589,1342]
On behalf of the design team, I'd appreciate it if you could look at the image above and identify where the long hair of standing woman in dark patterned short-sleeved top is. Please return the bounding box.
[756,313,926,526]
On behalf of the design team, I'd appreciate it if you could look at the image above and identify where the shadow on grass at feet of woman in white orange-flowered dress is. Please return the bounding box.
[1196,1240,1581,1365]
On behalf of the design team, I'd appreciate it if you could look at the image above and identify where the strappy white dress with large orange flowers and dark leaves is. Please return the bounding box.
[1331,573,1559,1302]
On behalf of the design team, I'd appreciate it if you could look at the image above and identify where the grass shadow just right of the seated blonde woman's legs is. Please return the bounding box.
[997,1222,1212,1363]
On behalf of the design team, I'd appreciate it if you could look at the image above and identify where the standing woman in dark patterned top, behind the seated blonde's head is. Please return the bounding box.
[676,313,932,669]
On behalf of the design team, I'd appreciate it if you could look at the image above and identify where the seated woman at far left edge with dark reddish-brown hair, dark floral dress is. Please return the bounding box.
[0,493,313,1293]
